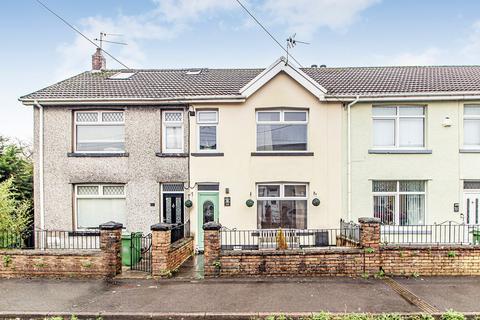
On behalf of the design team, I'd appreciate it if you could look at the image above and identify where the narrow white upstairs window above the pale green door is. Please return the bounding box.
[197,110,218,152]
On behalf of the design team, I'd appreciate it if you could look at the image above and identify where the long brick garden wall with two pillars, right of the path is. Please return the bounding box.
[205,218,480,277]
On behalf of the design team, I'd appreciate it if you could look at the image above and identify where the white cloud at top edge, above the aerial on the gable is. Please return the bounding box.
[262,0,380,39]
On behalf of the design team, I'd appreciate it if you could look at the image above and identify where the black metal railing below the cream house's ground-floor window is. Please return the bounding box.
[220,228,348,250]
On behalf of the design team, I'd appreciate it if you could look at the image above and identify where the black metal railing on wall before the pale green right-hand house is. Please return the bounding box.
[380,221,480,245]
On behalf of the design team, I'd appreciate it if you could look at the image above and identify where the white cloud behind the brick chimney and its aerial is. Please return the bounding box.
[55,0,236,79]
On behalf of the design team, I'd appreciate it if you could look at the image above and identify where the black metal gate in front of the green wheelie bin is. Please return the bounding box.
[130,232,152,273]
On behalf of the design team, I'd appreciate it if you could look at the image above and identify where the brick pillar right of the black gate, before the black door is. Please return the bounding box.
[150,223,172,278]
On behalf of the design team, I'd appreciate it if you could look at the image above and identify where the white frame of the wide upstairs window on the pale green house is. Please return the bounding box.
[372,104,427,150]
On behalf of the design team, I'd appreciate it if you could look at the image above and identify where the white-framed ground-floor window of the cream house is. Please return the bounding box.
[257,183,308,229]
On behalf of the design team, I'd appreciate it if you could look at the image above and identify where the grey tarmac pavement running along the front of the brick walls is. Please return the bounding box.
[0,278,480,313]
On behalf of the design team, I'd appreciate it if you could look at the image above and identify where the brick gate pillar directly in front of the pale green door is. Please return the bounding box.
[203,222,222,277]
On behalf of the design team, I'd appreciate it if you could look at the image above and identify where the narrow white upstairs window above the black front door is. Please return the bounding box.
[162,110,184,153]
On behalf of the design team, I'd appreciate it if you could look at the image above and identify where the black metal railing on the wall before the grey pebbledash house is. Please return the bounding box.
[0,230,100,250]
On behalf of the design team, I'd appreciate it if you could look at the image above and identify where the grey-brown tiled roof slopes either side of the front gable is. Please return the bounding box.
[20,66,480,100]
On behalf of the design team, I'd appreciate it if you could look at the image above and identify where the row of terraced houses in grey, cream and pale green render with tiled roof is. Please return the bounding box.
[20,51,480,250]
